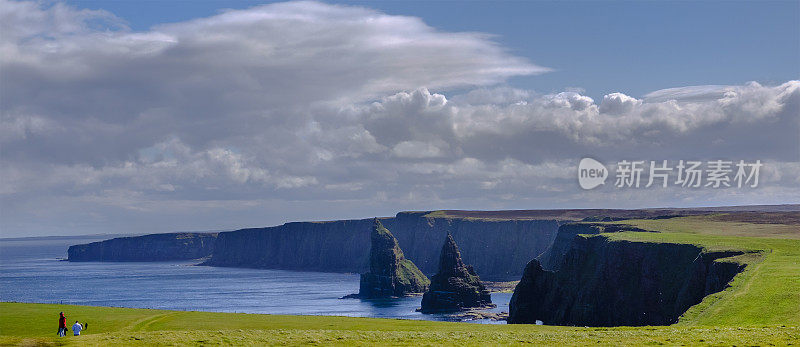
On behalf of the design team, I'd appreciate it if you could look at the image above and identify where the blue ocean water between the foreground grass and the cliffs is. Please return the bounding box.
[0,236,511,323]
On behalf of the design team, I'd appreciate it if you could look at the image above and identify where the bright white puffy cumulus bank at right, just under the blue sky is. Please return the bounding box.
[356,81,800,161]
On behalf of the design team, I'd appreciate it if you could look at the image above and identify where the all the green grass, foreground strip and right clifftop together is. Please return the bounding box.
[0,212,800,346]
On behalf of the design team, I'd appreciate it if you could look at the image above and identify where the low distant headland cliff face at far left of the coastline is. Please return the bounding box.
[67,233,217,261]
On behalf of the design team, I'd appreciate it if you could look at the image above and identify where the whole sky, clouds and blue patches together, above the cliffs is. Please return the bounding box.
[0,0,800,237]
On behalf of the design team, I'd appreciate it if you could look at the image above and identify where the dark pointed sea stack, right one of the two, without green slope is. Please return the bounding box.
[419,233,495,313]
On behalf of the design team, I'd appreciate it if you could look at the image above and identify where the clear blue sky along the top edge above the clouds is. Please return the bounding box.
[68,0,800,99]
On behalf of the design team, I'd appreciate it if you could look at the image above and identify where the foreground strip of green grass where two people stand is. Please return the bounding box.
[0,303,800,346]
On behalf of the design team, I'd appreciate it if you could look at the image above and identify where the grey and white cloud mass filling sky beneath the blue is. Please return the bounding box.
[0,1,800,238]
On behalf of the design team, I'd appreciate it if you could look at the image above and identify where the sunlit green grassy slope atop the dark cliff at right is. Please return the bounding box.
[600,213,800,326]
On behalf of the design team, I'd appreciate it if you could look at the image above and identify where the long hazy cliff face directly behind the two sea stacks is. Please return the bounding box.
[206,212,559,280]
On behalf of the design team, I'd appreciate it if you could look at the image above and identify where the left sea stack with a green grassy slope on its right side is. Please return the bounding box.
[358,218,431,299]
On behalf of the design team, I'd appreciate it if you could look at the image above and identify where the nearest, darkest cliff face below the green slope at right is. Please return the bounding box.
[508,235,745,326]
